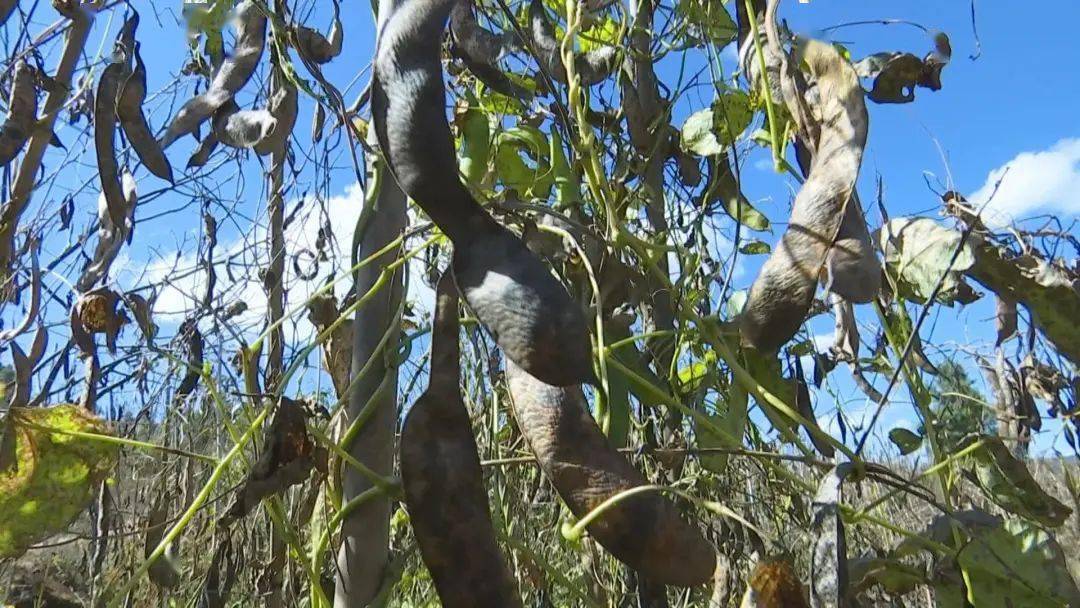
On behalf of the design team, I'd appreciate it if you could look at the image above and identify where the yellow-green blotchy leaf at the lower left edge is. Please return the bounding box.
[0,405,118,558]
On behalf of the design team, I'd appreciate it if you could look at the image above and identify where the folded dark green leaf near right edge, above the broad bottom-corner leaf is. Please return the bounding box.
[973,436,1072,528]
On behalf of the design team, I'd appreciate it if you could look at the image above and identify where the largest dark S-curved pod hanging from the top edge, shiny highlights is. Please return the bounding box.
[372,0,594,386]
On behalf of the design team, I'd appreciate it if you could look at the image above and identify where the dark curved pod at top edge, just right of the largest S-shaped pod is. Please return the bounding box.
[450,0,532,99]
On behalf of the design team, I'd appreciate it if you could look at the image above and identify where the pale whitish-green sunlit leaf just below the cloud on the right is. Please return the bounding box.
[880,217,975,303]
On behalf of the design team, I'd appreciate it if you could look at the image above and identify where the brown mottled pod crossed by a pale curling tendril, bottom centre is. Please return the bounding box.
[507,362,716,586]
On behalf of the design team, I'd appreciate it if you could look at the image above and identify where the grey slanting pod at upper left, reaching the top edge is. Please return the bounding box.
[161,0,267,148]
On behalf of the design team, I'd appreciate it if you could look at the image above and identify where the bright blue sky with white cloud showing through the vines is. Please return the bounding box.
[10,0,1080,457]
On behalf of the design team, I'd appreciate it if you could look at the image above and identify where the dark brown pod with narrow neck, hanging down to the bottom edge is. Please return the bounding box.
[400,271,522,608]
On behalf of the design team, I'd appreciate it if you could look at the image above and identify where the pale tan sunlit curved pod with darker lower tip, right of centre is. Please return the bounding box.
[741,41,868,351]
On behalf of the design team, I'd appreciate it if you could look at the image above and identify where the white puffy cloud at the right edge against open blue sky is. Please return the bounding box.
[970,138,1080,226]
